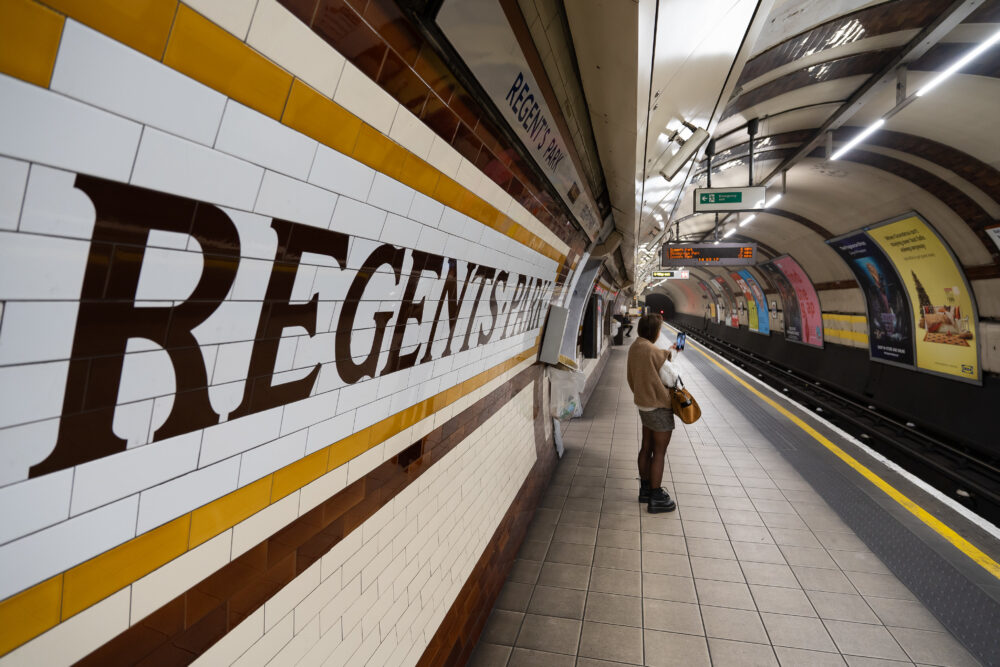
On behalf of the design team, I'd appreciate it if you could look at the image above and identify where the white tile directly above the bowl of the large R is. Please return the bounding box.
[131,127,264,211]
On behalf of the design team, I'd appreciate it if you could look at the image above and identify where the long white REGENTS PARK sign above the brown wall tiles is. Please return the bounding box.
[436,0,601,237]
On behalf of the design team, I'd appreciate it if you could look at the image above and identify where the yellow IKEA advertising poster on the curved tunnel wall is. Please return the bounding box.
[867,215,980,382]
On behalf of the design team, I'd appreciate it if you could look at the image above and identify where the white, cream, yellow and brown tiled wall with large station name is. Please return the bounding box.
[0,0,581,665]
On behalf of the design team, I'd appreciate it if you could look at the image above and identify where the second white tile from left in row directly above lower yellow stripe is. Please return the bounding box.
[137,456,240,534]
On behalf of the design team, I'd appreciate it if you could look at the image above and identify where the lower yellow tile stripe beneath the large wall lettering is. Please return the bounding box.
[0,344,538,655]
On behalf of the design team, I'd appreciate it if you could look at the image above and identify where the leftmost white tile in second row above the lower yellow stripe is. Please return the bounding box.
[0,469,71,544]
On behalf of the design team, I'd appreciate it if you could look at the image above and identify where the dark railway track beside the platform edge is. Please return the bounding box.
[671,323,1000,525]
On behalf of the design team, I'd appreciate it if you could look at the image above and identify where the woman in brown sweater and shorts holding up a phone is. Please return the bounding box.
[627,314,677,514]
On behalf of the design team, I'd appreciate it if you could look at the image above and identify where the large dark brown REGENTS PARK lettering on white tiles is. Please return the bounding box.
[30,175,551,477]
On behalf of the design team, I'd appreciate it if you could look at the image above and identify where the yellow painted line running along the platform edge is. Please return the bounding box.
[692,345,1000,579]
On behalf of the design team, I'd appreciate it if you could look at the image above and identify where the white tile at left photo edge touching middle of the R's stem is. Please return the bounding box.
[0,301,78,366]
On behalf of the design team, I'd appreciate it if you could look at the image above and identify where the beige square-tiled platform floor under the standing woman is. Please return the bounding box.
[470,339,978,667]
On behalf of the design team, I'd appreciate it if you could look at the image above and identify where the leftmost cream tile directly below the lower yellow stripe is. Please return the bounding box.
[0,588,129,667]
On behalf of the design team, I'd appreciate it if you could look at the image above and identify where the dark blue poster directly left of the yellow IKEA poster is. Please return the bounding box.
[827,232,914,366]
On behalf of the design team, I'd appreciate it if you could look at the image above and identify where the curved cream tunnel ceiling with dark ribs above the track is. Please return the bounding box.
[620,0,1000,317]
